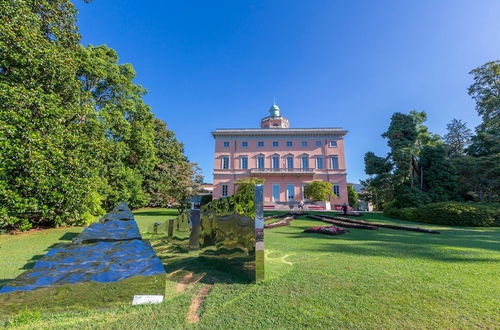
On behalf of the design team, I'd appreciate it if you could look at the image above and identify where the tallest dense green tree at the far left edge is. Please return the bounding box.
[0,0,102,229]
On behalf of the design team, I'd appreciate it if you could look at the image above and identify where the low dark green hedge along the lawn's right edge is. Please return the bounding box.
[384,202,500,227]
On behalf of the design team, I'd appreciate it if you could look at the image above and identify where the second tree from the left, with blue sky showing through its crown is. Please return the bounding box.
[77,45,157,208]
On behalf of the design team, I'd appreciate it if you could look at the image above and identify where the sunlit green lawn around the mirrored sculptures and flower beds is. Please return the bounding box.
[0,209,500,329]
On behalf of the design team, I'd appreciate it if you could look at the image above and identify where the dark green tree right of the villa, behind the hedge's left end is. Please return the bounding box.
[363,111,456,208]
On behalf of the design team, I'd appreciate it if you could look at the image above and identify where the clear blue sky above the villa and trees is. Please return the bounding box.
[75,0,500,182]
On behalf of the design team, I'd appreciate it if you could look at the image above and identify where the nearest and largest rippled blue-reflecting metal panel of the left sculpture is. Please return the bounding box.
[0,239,165,293]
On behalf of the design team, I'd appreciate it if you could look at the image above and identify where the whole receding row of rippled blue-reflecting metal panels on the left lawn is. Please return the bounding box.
[0,204,165,293]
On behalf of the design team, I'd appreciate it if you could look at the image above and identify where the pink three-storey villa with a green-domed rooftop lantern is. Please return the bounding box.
[212,105,347,209]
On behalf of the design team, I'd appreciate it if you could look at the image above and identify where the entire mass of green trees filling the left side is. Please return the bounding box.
[0,0,196,229]
